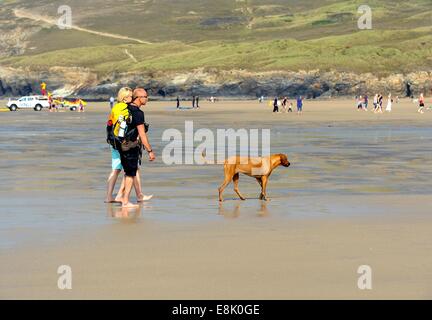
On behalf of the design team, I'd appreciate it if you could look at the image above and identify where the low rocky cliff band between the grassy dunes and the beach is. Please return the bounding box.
[0,67,432,99]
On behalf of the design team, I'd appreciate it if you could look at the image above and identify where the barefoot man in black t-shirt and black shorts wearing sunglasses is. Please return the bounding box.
[120,88,156,208]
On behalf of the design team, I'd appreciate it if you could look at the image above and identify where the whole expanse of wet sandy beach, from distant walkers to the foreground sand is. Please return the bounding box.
[0,100,432,299]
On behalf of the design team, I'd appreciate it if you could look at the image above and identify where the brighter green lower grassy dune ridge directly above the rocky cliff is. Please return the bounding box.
[2,28,432,74]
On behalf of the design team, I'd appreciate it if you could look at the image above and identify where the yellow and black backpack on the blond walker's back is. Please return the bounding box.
[106,102,135,150]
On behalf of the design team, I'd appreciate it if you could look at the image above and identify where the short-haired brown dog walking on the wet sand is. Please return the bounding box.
[219,153,290,201]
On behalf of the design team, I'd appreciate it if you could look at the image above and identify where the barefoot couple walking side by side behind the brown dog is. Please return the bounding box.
[105,87,156,208]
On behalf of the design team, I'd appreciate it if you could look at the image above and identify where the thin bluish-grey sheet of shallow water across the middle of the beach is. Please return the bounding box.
[0,103,432,248]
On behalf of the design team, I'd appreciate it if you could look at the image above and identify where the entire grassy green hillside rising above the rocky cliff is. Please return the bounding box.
[0,0,432,74]
